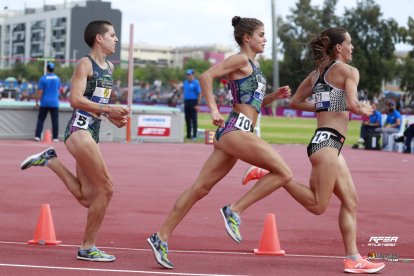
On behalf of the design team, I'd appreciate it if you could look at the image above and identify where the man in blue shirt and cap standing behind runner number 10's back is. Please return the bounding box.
[183,69,201,140]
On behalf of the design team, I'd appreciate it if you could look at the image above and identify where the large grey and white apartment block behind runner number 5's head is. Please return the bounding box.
[0,0,122,68]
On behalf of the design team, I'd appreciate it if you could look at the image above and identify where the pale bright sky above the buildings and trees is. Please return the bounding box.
[4,0,414,56]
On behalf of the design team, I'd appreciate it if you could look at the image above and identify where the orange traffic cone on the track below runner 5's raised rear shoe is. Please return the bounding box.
[27,204,62,245]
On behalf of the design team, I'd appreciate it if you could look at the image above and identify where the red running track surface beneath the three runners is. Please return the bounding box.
[0,140,414,275]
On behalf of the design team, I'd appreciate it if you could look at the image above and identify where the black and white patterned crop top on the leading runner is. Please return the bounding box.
[312,60,348,112]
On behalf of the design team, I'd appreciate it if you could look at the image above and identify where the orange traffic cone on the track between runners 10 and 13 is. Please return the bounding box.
[254,214,285,256]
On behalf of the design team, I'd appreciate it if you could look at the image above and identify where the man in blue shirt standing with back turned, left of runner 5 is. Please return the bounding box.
[35,62,60,142]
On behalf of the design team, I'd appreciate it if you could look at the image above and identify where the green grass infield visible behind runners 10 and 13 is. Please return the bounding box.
[198,113,361,145]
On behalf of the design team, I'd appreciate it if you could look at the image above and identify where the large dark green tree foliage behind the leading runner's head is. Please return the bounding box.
[277,0,414,99]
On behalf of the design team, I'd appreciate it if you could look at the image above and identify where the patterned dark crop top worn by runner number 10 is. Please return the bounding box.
[227,59,266,113]
